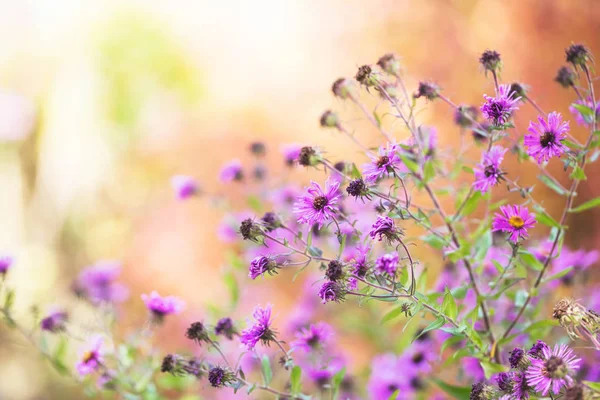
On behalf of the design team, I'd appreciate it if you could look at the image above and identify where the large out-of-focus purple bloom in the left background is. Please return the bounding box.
[74,261,129,304]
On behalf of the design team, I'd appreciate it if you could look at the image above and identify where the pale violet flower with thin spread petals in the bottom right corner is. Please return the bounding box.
[525,344,581,396]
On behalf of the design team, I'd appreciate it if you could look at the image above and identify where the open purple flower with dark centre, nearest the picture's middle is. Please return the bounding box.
[293,181,341,228]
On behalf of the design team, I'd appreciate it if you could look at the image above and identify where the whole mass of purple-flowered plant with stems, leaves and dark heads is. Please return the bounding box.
[0,45,600,400]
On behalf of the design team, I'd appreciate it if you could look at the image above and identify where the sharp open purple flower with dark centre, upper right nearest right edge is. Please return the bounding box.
[524,112,569,164]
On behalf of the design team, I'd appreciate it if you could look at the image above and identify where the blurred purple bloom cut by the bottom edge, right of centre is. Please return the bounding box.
[367,354,414,400]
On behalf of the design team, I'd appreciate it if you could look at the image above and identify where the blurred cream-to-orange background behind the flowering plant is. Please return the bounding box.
[0,0,600,399]
